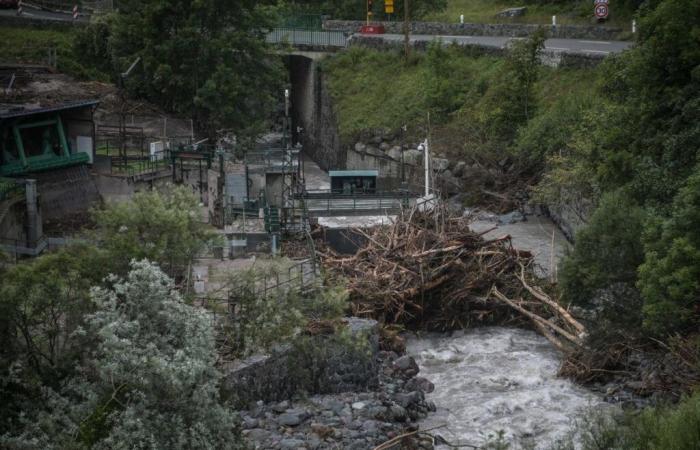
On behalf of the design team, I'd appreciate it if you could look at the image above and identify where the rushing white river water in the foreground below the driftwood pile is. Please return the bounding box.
[407,327,609,449]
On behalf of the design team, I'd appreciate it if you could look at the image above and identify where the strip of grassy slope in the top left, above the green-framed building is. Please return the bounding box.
[0,27,109,81]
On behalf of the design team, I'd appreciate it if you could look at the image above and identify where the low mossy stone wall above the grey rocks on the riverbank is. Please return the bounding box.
[221,318,379,407]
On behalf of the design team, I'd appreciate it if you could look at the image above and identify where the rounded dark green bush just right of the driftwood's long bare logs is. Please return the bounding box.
[560,191,645,304]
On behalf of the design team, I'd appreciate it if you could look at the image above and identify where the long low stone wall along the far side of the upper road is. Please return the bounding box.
[323,20,623,40]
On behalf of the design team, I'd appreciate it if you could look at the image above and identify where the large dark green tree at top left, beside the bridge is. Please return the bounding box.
[76,0,283,136]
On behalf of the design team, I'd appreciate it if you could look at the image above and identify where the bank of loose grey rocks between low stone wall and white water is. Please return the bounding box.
[241,352,436,450]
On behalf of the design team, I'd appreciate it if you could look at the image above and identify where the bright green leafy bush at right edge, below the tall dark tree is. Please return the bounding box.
[639,166,700,334]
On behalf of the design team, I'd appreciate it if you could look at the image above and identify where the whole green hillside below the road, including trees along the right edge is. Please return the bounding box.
[324,0,700,380]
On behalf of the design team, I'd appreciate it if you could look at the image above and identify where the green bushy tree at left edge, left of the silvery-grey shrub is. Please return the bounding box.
[0,246,106,435]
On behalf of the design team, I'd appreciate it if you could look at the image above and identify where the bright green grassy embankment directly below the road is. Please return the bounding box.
[324,44,596,152]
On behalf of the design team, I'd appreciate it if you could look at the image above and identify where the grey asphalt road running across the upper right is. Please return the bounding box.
[372,34,632,55]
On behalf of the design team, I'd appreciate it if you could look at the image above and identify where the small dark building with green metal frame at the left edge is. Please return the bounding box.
[0,100,99,177]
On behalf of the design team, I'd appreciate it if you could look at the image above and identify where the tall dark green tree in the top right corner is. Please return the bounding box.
[598,0,700,206]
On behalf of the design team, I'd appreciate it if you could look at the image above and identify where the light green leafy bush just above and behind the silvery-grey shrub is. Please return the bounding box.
[94,186,213,278]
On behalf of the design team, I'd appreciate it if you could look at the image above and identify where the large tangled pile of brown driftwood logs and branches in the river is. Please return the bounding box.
[318,207,585,349]
